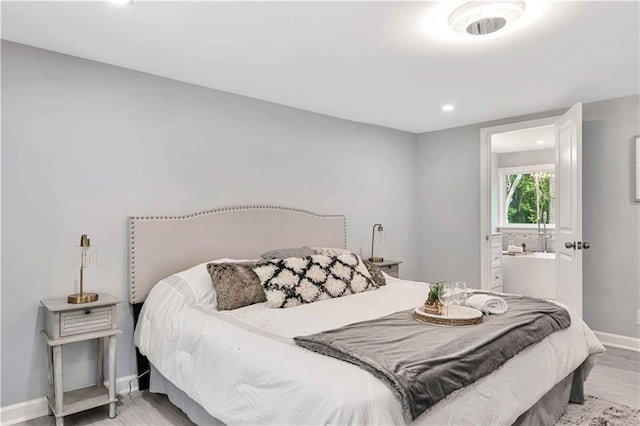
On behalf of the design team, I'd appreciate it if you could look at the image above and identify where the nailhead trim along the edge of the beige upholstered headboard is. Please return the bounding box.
[129,206,347,304]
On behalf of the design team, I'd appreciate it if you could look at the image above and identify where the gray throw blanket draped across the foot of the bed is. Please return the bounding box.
[294,295,571,421]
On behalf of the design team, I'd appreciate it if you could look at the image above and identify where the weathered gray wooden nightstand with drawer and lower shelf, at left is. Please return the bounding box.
[40,293,122,426]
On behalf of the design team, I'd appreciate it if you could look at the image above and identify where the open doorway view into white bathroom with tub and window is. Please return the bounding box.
[489,125,556,299]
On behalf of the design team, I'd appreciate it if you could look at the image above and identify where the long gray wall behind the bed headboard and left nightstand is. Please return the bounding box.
[1,42,417,406]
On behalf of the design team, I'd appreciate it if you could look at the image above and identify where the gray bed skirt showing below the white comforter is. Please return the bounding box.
[149,364,584,426]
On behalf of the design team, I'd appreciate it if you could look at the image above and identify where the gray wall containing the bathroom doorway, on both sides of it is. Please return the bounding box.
[416,95,640,337]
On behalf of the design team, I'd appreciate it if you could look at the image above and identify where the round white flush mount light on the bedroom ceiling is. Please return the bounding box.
[421,0,551,42]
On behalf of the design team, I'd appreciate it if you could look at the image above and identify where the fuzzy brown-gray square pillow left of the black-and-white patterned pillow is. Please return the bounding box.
[207,262,267,311]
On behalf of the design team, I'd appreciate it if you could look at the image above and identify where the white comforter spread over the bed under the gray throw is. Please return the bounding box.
[135,264,604,425]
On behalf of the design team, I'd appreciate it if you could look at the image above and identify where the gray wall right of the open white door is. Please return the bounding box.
[582,96,640,337]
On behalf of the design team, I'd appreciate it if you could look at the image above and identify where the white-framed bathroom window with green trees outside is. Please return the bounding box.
[498,164,555,226]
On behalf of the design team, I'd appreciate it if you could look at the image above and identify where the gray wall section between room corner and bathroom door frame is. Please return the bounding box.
[416,126,480,288]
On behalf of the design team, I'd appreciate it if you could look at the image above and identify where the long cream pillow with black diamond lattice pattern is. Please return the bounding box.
[253,253,378,308]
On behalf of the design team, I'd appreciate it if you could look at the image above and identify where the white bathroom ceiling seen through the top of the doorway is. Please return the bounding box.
[491,126,556,154]
